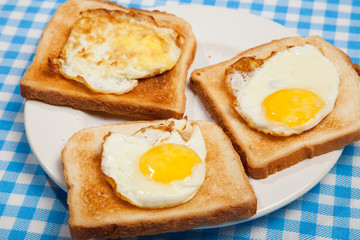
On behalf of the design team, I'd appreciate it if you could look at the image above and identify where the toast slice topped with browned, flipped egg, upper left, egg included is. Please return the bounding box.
[20,0,196,119]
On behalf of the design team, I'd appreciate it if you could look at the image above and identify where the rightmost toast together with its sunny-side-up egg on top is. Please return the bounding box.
[190,36,360,179]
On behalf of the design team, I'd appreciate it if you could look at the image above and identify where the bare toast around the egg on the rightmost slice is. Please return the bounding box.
[190,36,360,179]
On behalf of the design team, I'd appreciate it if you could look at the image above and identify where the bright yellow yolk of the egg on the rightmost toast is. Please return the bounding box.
[262,88,324,127]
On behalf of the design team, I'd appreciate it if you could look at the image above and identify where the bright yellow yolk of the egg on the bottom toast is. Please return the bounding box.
[139,143,201,184]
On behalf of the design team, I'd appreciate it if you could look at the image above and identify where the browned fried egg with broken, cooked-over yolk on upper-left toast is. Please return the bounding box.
[55,9,181,94]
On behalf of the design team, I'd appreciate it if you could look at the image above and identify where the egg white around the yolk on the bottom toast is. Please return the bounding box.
[101,121,207,208]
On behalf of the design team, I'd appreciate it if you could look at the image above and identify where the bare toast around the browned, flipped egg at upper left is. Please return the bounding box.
[20,0,196,119]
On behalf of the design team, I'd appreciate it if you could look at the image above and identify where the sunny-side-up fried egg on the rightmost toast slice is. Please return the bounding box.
[226,44,339,136]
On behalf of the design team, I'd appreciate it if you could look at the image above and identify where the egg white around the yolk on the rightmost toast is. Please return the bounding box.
[226,44,340,136]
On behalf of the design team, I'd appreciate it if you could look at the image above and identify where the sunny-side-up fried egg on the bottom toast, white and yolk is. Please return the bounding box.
[101,120,207,208]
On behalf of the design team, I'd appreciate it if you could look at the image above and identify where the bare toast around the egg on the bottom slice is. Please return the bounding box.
[62,121,257,239]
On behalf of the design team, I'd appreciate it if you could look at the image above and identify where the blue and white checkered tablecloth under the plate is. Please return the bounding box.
[0,0,360,239]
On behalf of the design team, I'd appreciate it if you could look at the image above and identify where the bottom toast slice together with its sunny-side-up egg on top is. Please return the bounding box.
[62,120,257,239]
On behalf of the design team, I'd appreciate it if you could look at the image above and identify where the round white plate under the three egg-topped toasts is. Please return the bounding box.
[25,5,342,228]
